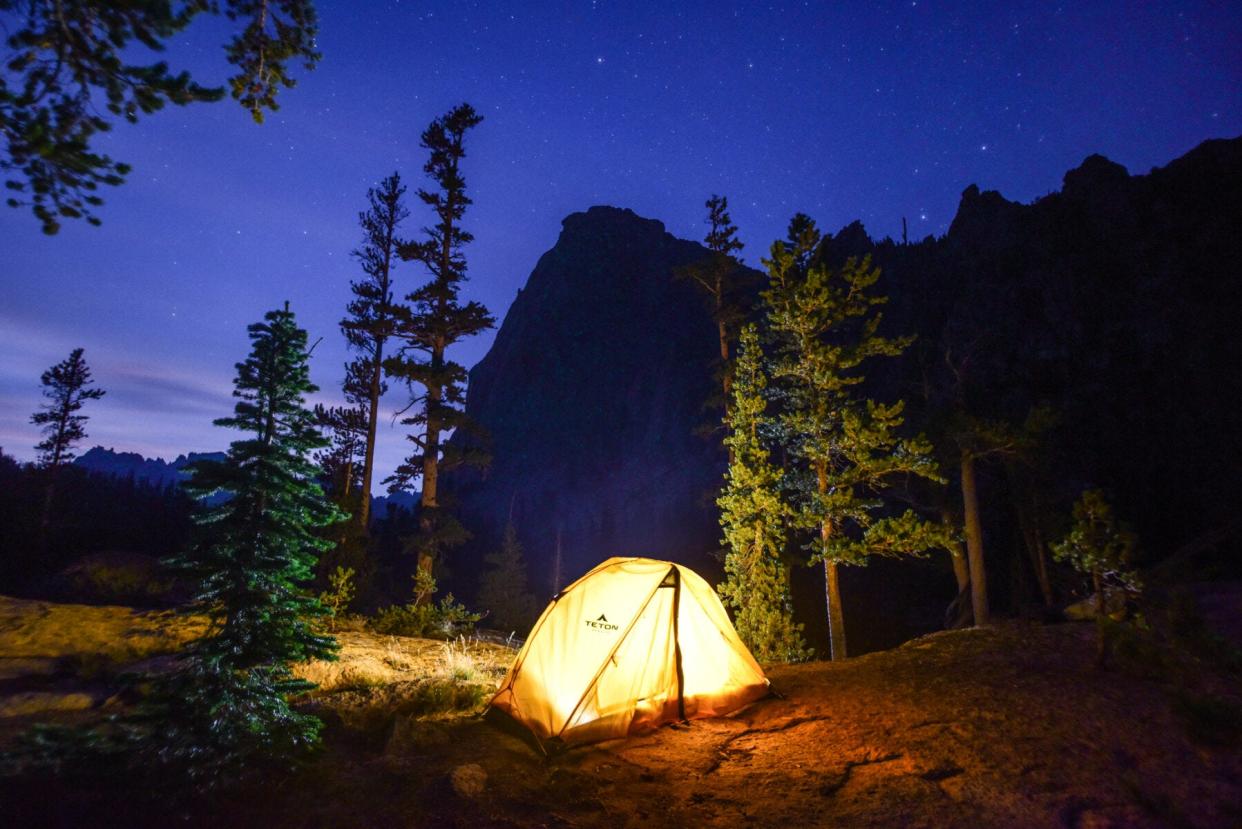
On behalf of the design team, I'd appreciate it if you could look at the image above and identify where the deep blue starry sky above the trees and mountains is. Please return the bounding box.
[0,0,1242,487]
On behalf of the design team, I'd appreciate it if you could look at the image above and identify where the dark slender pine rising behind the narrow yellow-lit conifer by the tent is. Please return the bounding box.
[676,195,749,411]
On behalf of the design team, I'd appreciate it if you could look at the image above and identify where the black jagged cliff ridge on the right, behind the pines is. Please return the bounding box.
[844,138,1242,561]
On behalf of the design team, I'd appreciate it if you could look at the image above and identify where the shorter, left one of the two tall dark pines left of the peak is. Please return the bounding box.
[340,173,410,531]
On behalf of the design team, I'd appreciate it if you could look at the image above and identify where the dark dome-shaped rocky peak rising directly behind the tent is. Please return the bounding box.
[453,208,724,597]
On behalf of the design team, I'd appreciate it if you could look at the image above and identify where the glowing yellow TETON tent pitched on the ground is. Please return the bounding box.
[491,558,768,748]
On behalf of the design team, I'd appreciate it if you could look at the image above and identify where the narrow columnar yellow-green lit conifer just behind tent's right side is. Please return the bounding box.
[717,326,811,662]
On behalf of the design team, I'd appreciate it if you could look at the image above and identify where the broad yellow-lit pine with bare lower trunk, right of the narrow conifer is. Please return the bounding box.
[764,215,948,659]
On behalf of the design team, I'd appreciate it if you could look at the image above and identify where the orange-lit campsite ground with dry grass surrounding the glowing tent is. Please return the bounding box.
[0,599,1242,828]
